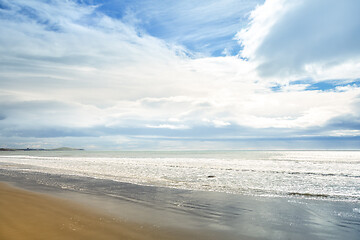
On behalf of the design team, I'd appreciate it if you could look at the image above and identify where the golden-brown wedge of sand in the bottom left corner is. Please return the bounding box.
[0,183,199,240]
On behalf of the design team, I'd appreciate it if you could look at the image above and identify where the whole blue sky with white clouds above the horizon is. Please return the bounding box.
[0,0,360,150]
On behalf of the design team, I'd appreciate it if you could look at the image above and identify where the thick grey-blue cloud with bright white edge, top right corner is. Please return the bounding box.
[237,0,360,81]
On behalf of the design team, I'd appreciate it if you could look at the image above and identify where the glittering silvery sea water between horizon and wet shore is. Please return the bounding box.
[0,151,360,201]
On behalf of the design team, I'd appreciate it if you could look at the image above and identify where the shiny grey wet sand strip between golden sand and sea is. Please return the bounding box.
[0,169,360,240]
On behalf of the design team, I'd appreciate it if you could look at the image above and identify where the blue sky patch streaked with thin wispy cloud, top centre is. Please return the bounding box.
[90,0,263,55]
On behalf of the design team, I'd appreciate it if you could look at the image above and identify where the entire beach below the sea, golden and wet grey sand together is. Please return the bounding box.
[0,168,360,240]
